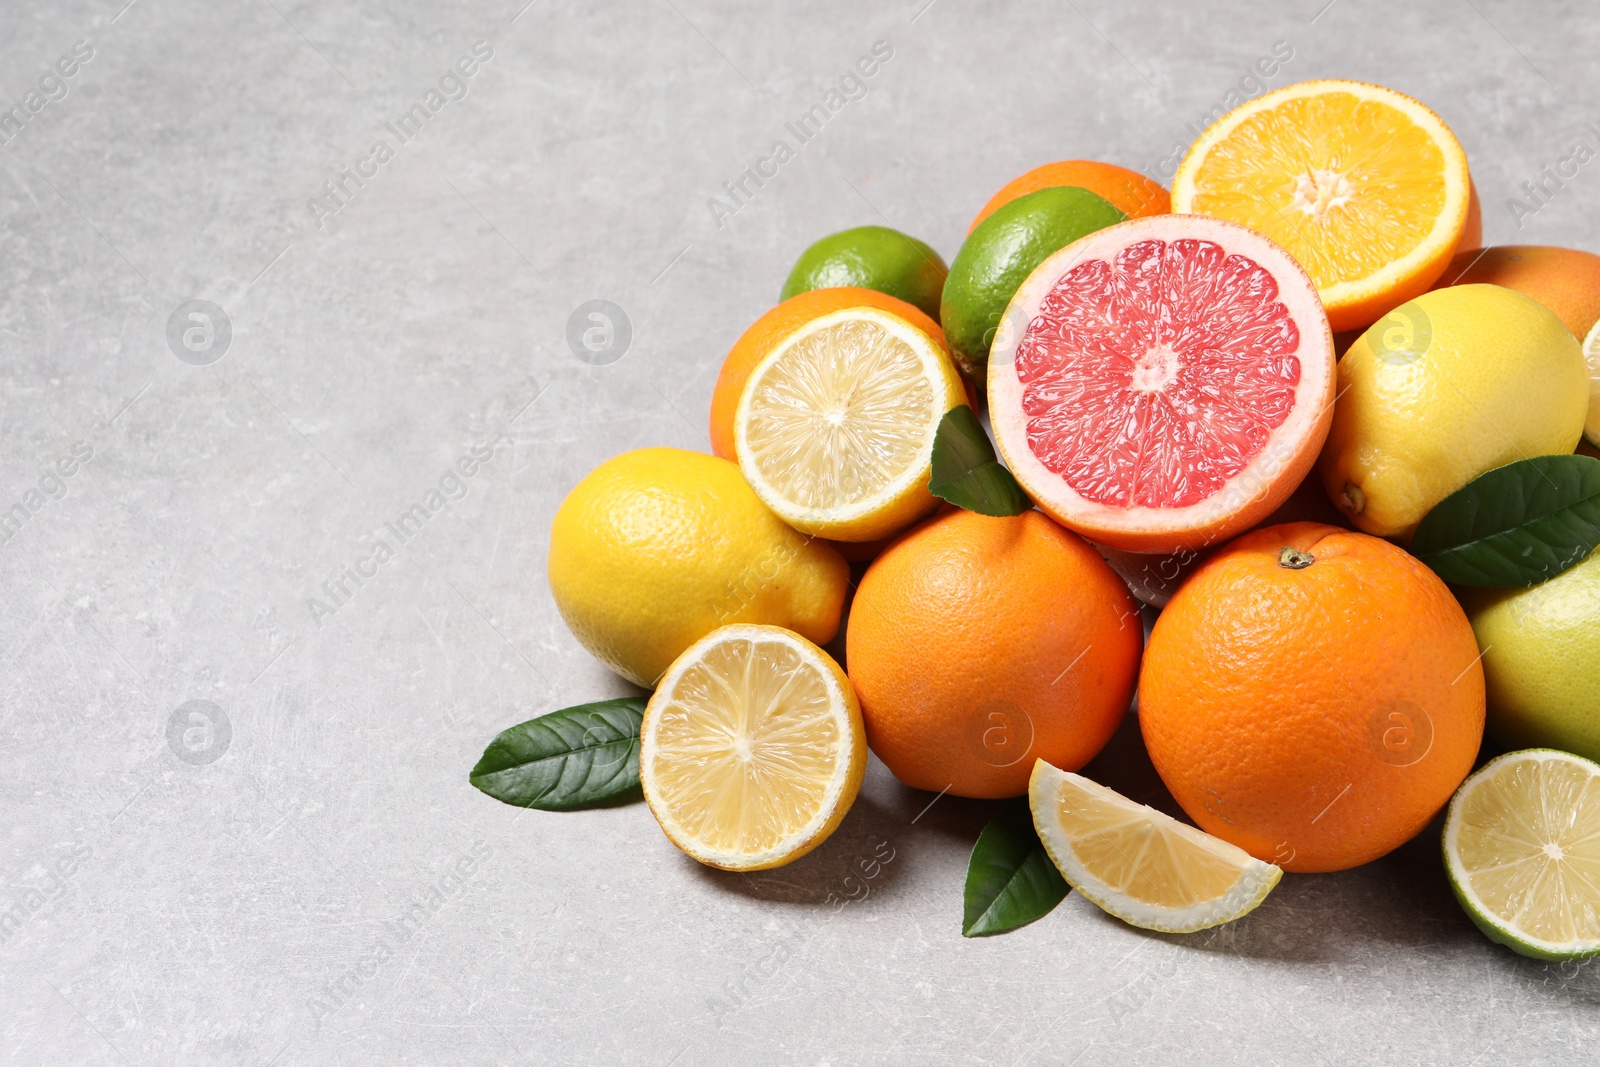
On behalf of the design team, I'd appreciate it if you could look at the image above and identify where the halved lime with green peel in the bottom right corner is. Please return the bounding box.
[1445,749,1600,960]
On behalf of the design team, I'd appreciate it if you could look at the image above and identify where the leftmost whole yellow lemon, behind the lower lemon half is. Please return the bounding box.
[549,448,850,688]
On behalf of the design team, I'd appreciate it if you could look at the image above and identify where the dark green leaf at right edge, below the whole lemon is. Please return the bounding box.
[1411,456,1600,589]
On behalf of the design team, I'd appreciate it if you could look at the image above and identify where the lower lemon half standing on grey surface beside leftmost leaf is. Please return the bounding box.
[640,625,867,870]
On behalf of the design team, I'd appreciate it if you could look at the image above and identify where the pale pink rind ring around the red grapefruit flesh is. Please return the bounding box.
[989,214,1336,552]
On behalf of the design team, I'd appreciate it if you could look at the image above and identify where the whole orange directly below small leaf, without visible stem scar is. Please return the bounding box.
[845,510,1144,797]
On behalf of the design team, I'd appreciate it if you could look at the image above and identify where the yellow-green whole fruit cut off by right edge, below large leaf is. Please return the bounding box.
[1467,552,1600,760]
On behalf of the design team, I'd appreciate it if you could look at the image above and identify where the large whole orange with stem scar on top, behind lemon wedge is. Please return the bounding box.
[1139,523,1483,872]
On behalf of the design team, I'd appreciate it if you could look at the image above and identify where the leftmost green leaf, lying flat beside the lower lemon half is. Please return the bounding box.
[469,696,646,811]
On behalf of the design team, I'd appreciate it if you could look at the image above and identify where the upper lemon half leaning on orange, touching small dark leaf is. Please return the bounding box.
[734,307,965,541]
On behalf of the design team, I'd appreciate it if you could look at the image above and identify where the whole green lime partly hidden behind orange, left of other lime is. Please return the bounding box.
[778,226,949,318]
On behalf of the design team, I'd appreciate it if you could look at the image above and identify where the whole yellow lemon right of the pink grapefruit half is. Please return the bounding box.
[1318,285,1589,537]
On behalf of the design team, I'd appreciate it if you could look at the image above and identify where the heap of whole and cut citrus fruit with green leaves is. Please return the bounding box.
[472,80,1600,960]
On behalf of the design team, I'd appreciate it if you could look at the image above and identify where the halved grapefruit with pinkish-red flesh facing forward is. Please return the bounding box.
[989,214,1334,552]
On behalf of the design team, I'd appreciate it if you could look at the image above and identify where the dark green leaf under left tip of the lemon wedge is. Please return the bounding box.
[962,801,1067,937]
